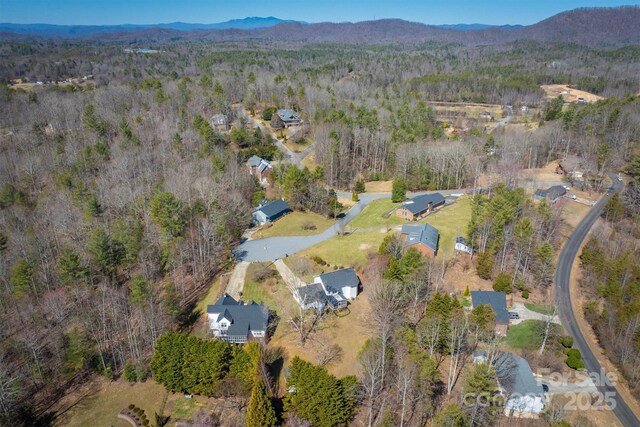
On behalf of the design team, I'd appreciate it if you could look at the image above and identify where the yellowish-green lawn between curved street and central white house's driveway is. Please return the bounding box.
[297,231,386,267]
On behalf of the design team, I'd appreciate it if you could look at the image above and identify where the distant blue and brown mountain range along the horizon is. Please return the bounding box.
[0,6,640,46]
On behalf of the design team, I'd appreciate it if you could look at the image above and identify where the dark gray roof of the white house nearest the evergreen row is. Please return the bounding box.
[207,294,269,337]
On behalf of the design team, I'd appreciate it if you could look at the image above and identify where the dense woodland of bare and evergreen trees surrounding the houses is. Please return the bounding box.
[0,25,640,425]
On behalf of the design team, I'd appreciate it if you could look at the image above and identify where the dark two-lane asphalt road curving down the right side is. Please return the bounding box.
[555,176,640,427]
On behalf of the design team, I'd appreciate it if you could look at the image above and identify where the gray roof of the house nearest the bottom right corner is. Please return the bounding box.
[493,353,543,395]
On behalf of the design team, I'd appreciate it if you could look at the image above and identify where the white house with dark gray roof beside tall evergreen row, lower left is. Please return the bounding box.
[207,294,269,343]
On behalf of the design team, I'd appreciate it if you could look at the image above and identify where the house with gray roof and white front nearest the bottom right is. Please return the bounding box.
[492,353,545,418]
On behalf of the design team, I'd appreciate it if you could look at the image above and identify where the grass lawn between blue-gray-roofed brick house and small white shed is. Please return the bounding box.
[419,197,471,257]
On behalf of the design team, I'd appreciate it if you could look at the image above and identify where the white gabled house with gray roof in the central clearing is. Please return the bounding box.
[293,268,360,310]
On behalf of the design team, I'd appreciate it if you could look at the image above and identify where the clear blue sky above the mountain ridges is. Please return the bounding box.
[0,0,630,25]
